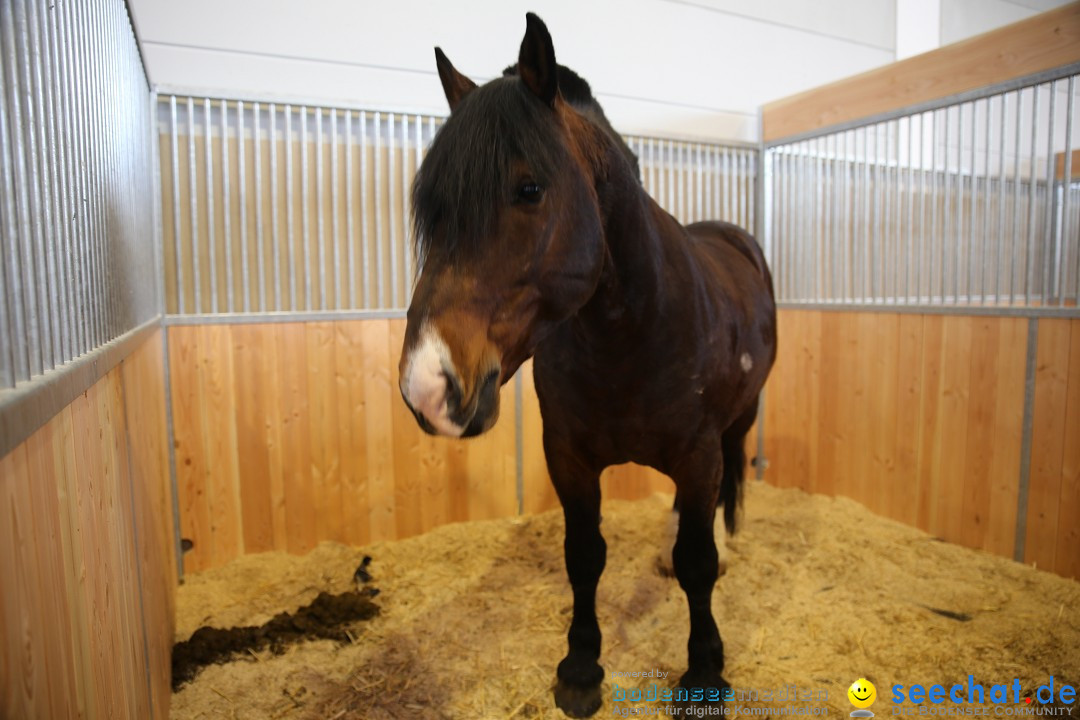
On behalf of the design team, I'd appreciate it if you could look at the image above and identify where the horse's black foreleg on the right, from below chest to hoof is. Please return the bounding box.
[672,452,728,697]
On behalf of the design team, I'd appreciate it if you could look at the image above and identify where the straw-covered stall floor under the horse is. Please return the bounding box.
[173,483,1080,720]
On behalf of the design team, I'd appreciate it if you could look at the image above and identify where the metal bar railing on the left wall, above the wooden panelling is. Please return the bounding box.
[0,0,158,390]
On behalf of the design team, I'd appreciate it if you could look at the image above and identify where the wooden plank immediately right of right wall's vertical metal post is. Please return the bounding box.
[1024,318,1075,570]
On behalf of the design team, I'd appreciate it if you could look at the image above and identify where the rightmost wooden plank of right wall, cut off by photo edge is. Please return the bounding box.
[1054,320,1080,580]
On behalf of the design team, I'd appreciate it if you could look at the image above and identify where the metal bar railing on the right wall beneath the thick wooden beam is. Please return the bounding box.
[764,67,1080,314]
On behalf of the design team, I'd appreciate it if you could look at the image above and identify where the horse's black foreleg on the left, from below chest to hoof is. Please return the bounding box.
[548,453,607,718]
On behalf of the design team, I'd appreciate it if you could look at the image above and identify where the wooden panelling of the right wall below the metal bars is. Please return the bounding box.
[765,310,1080,578]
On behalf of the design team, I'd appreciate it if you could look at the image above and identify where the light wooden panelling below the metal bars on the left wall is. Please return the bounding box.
[0,332,176,720]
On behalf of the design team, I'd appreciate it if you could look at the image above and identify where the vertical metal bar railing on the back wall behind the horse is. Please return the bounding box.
[157,94,757,316]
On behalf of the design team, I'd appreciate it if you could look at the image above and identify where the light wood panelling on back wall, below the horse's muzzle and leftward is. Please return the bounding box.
[168,320,517,570]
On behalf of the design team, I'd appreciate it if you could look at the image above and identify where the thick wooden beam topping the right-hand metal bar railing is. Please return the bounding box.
[761,3,1080,141]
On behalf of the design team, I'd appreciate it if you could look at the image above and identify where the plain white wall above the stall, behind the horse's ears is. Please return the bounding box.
[130,0,1061,140]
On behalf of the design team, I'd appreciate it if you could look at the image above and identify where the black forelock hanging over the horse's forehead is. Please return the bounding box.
[413,77,565,259]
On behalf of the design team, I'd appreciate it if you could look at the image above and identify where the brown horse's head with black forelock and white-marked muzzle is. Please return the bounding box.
[401,14,605,436]
